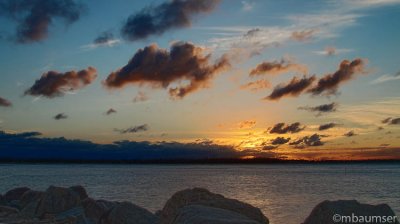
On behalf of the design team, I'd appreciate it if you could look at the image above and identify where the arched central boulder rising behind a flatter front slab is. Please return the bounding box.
[160,188,269,224]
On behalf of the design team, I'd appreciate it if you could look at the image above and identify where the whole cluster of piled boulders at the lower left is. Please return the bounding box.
[0,186,158,224]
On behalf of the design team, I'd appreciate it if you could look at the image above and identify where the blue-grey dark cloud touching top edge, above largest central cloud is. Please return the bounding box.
[121,0,220,41]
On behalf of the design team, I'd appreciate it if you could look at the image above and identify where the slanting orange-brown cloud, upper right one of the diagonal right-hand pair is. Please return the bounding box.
[309,58,366,95]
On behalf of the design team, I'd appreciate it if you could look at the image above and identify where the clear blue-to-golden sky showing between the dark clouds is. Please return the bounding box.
[0,0,400,161]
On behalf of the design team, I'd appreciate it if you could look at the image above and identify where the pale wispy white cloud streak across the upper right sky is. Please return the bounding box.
[200,0,400,57]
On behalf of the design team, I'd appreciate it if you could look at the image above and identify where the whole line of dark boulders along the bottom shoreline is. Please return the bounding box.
[0,186,399,224]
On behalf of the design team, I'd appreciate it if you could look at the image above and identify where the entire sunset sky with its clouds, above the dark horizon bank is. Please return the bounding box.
[0,0,400,159]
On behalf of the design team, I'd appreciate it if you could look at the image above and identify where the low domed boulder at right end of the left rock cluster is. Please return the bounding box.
[100,202,158,224]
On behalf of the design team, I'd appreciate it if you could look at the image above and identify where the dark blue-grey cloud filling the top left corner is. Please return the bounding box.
[0,0,84,43]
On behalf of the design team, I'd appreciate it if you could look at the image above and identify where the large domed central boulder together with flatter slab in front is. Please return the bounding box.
[160,188,269,224]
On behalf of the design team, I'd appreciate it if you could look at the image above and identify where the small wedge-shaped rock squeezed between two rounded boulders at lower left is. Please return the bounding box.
[82,198,116,223]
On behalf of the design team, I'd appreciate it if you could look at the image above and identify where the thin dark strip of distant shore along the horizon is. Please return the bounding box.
[0,158,400,165]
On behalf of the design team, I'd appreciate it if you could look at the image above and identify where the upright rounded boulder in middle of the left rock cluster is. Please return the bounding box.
[36,186,81,217]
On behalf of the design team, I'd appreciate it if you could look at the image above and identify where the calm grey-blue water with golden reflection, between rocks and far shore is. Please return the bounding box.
[0,164,400,224]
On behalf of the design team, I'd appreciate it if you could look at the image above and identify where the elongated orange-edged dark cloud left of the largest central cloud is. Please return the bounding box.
[25,67,97,98]
